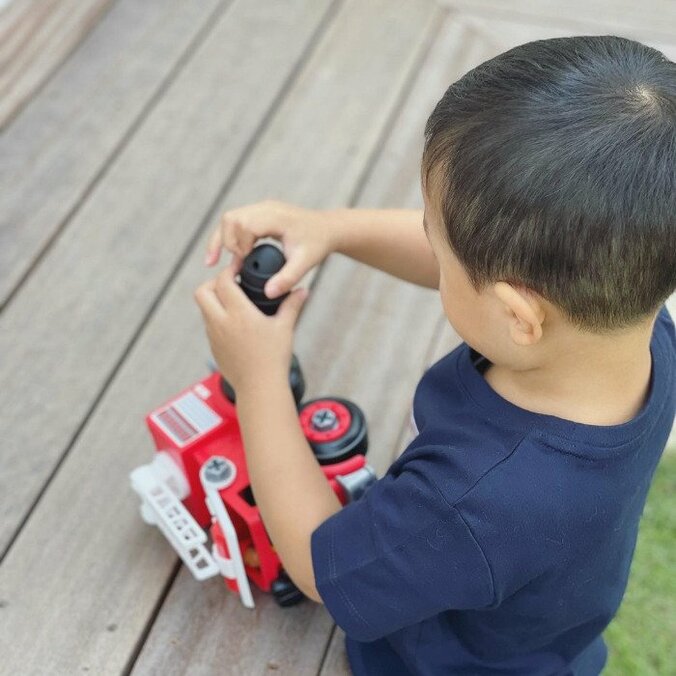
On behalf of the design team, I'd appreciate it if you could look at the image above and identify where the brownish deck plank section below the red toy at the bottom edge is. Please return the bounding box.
[132,580,332,676]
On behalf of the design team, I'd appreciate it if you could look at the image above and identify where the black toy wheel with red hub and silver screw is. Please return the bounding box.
[299,397,368,465]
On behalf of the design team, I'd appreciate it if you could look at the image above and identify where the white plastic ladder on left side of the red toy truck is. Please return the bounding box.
[130,452,220,580]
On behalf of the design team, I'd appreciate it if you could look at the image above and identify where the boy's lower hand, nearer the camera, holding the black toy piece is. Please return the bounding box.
[195,256,308,392]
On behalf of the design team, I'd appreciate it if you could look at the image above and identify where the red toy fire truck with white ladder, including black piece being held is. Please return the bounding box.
[131,244,376,608]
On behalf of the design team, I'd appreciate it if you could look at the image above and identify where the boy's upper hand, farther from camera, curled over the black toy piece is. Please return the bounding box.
[204,200,334,298]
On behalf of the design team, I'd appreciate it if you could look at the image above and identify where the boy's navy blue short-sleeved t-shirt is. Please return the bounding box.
[312,308,676,676]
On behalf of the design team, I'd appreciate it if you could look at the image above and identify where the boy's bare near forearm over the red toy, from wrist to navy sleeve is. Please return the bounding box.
[237,375,341,603]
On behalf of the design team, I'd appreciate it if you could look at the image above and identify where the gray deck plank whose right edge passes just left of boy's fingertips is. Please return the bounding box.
[0,0,336,551]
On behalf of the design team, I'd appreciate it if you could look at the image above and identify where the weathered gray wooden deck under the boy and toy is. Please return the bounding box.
[0,0,676,676]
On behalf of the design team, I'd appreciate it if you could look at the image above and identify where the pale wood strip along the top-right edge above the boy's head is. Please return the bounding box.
[440,0,676,42]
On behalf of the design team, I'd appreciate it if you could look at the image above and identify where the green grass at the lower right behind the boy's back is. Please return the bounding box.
[603,449,676,676]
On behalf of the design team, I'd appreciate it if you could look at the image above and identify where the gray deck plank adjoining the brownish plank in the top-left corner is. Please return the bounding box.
[0,0,228,310]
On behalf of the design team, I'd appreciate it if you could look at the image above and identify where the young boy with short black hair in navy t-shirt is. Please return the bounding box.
[196,36,676,676]
